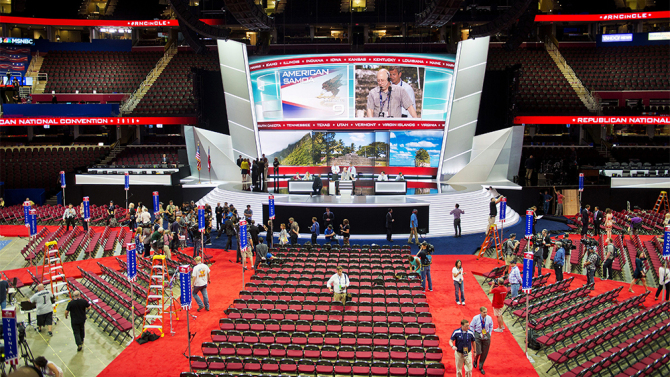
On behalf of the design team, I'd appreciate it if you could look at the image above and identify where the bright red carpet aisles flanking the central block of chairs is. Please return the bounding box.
[99,251,537,377]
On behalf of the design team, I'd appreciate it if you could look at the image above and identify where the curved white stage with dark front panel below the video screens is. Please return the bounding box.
[189,176,521,239]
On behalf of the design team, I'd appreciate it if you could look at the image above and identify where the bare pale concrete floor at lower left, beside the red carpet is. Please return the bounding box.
[0,238,126,377]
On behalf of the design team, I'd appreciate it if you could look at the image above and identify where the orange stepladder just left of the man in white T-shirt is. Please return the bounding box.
[142,255,169,338]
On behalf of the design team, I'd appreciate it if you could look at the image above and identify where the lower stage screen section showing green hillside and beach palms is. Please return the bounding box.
[259,131,389,166]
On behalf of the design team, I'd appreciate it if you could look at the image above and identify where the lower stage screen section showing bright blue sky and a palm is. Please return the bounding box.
[389,131,444,168]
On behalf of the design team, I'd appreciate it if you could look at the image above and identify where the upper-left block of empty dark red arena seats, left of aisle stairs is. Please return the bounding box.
[40,51,162,93]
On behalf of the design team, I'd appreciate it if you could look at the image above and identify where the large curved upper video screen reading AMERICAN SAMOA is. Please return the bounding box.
[249,54,455,131]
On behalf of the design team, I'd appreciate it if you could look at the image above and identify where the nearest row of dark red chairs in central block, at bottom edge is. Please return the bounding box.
[186,356,445,377]
